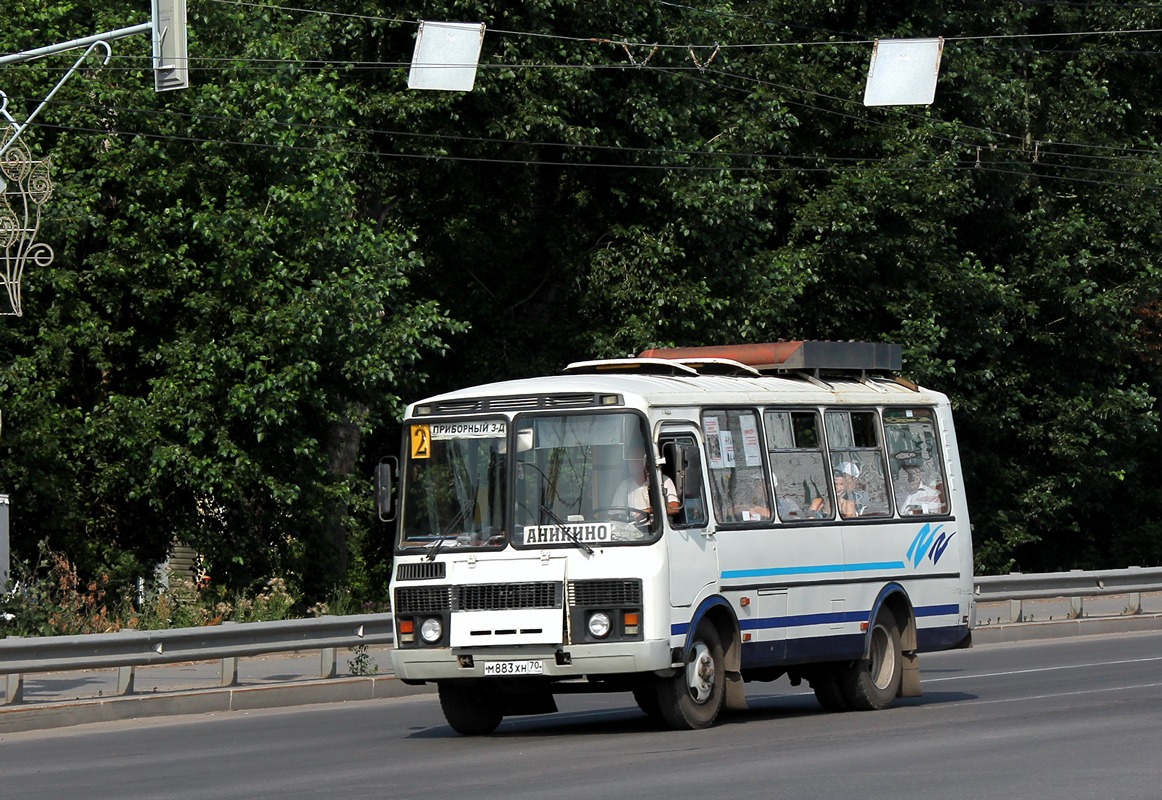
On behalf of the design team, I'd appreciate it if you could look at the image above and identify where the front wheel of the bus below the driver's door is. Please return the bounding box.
[658,620,726,730]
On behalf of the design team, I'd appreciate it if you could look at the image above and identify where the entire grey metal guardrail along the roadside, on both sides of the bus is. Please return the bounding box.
[0,567,1162,705]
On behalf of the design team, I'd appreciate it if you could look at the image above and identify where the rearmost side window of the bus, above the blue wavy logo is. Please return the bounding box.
[883,408,948,516]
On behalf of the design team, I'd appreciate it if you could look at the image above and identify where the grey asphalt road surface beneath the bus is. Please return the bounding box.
[0,633,1162,800]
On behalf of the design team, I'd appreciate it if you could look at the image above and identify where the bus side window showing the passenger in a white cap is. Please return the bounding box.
[826,410,891,519]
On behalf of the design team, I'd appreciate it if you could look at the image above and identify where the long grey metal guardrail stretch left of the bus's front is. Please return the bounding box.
[0,614,394,705]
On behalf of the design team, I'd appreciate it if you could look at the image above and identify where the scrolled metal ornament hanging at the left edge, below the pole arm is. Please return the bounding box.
[0,126,53,316]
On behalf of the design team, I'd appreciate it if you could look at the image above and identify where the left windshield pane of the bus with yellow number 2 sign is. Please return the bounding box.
[400,420,508,556]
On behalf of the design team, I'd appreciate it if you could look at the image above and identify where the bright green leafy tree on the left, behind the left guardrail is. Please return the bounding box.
[0,5,457,599]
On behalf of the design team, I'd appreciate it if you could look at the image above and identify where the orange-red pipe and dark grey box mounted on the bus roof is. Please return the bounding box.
[640,341,903,374]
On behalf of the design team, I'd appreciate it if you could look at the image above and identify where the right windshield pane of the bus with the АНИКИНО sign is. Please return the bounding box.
[512,413,661,549]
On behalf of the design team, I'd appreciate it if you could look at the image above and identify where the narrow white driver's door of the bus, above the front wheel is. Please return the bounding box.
[658,429,718,607]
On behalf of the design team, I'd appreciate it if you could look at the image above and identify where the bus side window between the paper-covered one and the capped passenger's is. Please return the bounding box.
[765,410,834,522]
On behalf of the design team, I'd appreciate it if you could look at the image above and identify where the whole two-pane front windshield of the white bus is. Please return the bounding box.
[400,412,661,548]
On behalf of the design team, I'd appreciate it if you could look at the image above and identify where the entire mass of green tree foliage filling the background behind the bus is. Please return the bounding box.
[0,0,1162,598]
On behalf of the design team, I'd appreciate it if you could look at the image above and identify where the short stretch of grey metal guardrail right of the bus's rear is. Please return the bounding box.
[974,566,1162,622]
